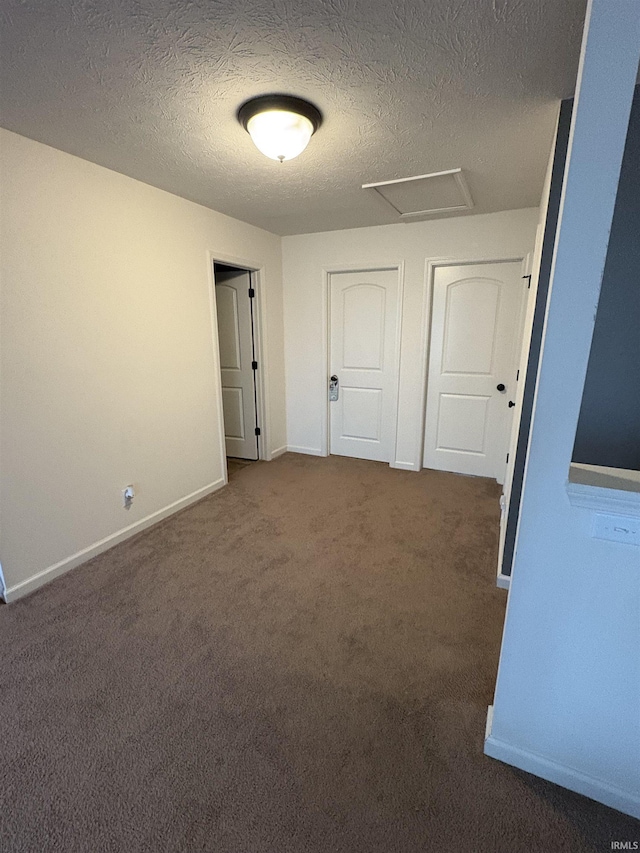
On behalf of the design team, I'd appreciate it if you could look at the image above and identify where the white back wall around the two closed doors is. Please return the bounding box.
[282,208,538,470]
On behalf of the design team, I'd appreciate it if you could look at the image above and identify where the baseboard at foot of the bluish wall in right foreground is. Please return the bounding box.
[484,724,640,818]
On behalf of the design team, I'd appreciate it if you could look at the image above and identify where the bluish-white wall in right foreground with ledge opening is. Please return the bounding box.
[485,0,640,817]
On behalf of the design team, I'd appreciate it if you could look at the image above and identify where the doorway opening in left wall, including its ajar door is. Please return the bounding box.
[213,261,263,478]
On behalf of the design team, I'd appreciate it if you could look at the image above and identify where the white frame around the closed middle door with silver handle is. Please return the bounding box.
[320,261,404,466]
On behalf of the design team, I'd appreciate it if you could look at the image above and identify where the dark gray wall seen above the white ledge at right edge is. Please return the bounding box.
[573,87,640,471]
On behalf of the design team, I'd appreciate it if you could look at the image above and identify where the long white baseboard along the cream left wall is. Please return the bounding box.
[3,477,227,604]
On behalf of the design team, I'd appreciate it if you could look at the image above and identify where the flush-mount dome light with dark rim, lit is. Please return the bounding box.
[238,95,322,163]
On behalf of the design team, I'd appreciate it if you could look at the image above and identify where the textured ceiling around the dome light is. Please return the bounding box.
[0,0,585,234]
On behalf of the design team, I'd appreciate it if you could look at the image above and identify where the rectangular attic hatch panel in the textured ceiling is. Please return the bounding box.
[362,169,473,219]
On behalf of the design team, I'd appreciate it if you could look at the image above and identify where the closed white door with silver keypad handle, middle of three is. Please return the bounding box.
[329,269,399,462]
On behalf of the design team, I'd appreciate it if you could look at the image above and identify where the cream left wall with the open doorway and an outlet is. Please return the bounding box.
[0,131,286,598]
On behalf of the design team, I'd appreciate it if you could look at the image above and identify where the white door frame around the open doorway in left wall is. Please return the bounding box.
[207,250,271,483]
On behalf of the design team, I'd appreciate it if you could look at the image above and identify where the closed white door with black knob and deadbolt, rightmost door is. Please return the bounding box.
[424,262,527,483]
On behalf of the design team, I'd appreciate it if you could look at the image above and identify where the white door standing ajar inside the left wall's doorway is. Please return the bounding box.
[215,270,258,459]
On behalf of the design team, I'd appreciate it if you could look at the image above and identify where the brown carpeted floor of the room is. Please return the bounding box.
[0,454,640,853]
